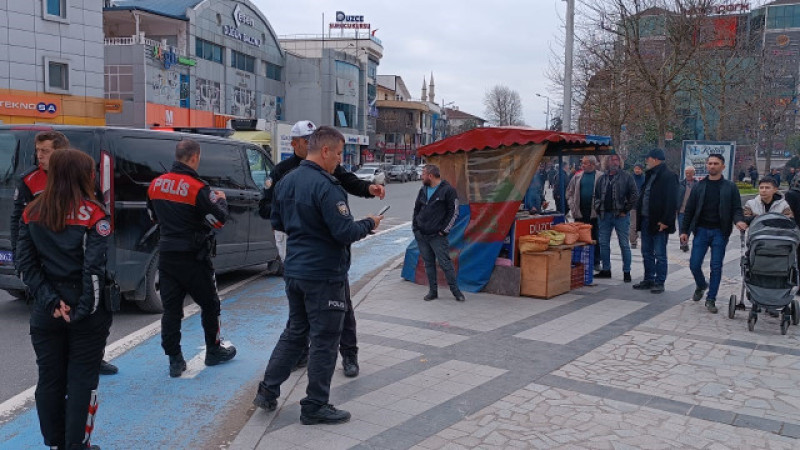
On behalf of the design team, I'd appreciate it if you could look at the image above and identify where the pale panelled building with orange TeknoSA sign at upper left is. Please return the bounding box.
[0,0,105,125]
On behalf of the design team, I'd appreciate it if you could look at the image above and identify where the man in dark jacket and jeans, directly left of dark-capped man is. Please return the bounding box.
[594,155,639,283]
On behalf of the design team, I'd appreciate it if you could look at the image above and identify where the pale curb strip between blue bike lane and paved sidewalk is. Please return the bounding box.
[227,257,404,450]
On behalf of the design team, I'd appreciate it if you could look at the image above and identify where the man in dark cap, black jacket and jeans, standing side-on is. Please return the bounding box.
[633,148,678,294]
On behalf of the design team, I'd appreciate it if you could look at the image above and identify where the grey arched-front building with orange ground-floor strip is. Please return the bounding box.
[103,0,285,128]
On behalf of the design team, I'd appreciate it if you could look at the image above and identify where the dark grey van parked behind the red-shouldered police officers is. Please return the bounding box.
[0,125,280,312]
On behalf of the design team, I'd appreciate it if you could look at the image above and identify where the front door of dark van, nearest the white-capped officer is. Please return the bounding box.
[244,146,278,264]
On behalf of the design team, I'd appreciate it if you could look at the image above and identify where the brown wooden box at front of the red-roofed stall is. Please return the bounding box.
[520,248,572,298]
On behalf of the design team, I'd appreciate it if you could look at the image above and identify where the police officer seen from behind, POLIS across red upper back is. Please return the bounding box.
[147,139,236,377]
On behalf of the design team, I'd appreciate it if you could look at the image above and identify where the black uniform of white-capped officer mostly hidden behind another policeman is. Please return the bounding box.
[259,154,374,359]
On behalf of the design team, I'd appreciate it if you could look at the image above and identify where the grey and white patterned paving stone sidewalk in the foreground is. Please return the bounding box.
[230,236,800,450]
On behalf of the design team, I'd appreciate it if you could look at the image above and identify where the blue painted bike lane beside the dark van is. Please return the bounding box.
[0,225,413,450]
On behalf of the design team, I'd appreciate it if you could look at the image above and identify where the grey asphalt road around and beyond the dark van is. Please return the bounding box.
[0,181,421,403]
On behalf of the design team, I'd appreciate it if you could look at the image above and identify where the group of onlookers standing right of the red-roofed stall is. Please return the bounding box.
[523,148,800,313]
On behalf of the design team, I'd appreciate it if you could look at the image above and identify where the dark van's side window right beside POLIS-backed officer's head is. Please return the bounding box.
[197,141,247,189]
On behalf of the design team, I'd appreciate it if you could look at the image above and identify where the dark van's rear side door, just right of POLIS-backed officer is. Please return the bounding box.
[191,137,247,271]
